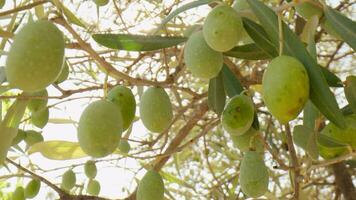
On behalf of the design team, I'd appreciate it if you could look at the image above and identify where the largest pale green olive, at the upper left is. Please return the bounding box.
[6,20,64,92]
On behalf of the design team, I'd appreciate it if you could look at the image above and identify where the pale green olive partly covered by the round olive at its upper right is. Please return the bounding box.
[184,31,223,79]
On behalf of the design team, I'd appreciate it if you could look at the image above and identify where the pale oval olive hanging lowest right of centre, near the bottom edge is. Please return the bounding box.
[239,151,268,198]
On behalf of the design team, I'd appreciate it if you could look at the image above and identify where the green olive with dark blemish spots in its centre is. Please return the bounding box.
[221,95,255,135]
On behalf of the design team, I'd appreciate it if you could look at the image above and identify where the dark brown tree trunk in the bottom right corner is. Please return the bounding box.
[332,162,356,200]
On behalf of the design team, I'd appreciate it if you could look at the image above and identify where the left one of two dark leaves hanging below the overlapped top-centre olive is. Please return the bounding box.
[208,72,226,116]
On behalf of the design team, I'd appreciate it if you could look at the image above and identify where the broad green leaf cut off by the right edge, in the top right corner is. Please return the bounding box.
[324,6,356,51]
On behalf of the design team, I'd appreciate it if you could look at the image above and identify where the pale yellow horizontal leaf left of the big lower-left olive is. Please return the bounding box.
[28,140,88,160]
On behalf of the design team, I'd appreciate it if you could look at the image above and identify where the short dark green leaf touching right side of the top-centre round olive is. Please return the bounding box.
[242,17,278,58]
